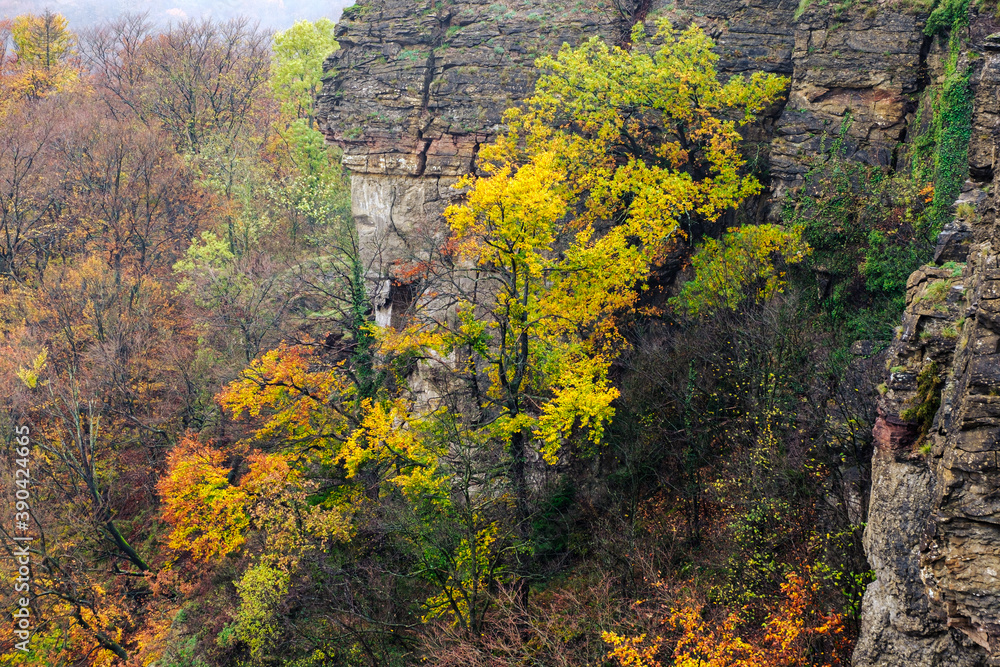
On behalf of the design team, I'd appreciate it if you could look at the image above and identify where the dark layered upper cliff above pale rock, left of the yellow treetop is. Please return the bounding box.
[317,0,615,177]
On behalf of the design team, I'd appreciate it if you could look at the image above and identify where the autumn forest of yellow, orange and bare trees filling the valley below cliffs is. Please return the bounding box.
[0,2,971,667]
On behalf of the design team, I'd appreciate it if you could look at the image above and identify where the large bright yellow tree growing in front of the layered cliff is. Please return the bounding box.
[385,22,787,628]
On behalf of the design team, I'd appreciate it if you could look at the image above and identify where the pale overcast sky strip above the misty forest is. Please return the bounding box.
[0,0,355,30]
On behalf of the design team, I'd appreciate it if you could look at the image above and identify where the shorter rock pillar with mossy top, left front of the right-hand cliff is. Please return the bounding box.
[854,258,984,667]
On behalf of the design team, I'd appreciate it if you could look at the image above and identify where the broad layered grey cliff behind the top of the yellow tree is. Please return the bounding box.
[317,0,925,280]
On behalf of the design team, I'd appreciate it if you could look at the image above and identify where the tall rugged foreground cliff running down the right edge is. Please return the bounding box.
[855,16,1000,666]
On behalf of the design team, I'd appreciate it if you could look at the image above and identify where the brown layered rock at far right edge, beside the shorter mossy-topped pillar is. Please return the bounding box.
[920,242,1000,658]
